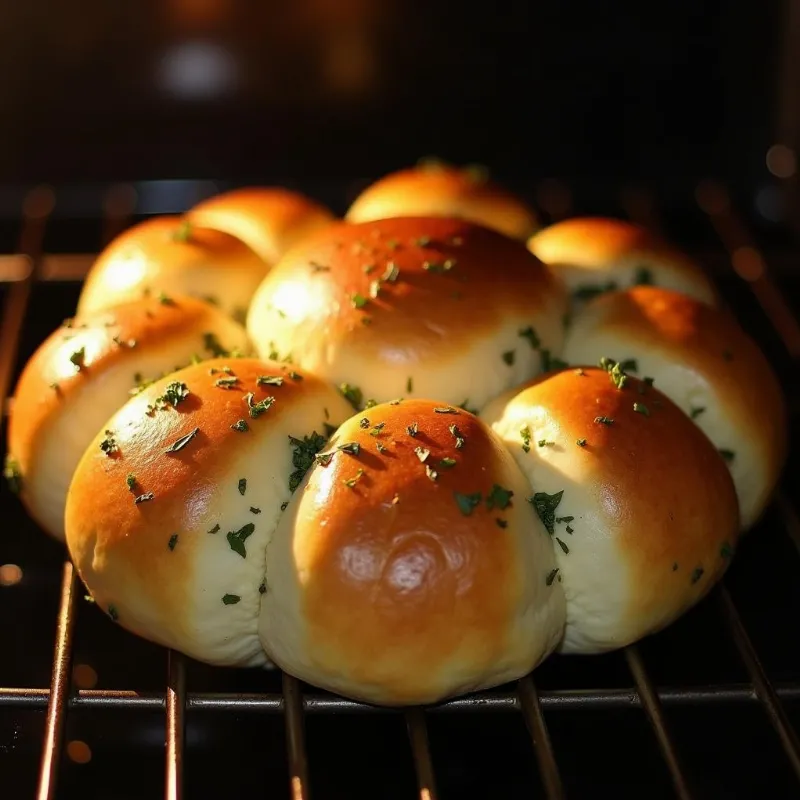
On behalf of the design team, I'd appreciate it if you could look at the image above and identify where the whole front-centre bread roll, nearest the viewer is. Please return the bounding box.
[259,400,564,705]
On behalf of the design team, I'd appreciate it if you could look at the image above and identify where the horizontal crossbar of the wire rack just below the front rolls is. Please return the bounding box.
[0,682,800,715]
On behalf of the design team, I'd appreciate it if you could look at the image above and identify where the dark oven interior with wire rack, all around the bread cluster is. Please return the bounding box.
[0,0,800,800]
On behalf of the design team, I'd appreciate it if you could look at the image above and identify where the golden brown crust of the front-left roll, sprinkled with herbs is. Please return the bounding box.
[65,359,341,638]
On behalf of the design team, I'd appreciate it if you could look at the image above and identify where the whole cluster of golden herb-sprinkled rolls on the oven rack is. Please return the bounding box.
[5,163,786,705]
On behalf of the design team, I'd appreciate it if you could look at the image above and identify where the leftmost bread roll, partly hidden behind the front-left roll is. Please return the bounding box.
[7,296,249,540]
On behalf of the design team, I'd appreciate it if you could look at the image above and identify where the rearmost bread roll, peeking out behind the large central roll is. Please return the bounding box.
[347,162,538,241]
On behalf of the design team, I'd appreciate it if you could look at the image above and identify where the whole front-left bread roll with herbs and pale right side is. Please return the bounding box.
[65,359,349,666]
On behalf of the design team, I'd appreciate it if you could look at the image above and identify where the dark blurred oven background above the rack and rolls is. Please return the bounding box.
[0,0,789,208]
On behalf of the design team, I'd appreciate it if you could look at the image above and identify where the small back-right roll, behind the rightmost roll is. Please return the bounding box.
[528,217,717,305]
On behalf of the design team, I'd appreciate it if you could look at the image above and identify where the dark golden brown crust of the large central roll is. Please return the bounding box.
[248,217,563,364]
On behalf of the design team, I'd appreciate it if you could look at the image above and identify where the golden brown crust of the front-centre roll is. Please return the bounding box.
[296,400,544,703]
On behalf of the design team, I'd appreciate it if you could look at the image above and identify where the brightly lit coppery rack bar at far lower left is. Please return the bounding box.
[36,561,77,800]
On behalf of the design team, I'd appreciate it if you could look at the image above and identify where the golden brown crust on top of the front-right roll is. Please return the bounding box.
[490,368,739,619]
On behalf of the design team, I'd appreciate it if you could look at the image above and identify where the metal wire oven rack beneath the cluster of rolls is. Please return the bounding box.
[0,183,800,800]
